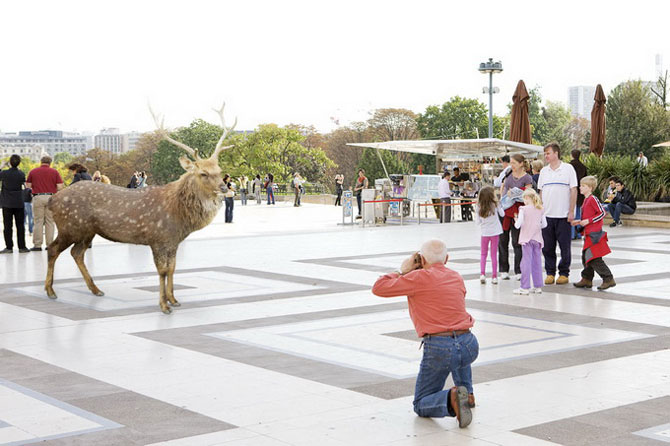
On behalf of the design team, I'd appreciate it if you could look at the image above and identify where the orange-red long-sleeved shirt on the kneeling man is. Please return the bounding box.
[372,264,475,337]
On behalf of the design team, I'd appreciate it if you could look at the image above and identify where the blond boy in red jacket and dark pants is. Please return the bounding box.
[572,176,616,290]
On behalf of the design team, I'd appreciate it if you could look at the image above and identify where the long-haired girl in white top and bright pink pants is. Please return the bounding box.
[475,186,505,284]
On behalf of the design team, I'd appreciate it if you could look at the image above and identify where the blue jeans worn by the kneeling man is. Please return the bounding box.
[414,333,479,417]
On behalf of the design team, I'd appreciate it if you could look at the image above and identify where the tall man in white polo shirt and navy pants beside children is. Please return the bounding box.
[537,142,577,285]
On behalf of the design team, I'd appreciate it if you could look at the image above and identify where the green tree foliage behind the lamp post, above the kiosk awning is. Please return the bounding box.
[416,96,503,139]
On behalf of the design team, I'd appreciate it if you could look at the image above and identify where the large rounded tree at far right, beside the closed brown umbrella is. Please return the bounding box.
[605,80,670,158]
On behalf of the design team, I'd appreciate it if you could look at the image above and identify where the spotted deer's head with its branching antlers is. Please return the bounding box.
[149,102,237,197]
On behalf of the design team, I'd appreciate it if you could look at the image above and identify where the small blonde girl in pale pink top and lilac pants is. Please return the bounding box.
[514,189,547,294]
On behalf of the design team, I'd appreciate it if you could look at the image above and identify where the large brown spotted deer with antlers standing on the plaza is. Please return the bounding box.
[44,103,237,314]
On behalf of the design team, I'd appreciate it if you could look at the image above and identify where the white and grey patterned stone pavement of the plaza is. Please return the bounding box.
[0,202,670,446]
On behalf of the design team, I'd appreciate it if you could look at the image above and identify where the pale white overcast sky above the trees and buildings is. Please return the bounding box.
[0,0,670,132]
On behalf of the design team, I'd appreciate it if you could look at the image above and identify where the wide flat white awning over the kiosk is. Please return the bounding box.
[347,138,543,161]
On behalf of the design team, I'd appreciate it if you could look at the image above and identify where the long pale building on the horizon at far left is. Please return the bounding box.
[0,130,87,159]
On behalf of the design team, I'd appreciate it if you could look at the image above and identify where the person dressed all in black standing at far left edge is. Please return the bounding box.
[0,154,30,254]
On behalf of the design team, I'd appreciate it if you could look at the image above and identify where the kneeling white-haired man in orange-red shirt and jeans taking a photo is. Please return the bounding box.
[372,240,479,427]
